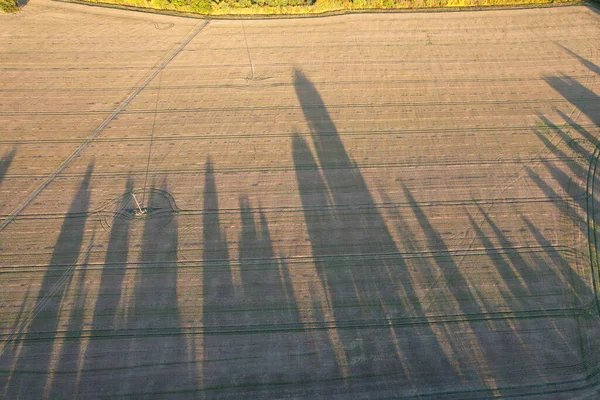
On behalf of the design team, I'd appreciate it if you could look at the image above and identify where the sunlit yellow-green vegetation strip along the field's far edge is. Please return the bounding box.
[72,0,582,16]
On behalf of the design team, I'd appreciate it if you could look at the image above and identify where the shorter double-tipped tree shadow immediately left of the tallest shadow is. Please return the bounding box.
[234,197,301,390]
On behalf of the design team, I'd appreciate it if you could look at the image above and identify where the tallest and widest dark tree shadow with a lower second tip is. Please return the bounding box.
[292,71,461,392]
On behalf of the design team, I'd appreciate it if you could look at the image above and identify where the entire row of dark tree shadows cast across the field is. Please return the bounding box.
[0,56,600,399]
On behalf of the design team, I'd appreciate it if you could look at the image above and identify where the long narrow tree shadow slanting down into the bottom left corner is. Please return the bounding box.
[5,164,93,399]
